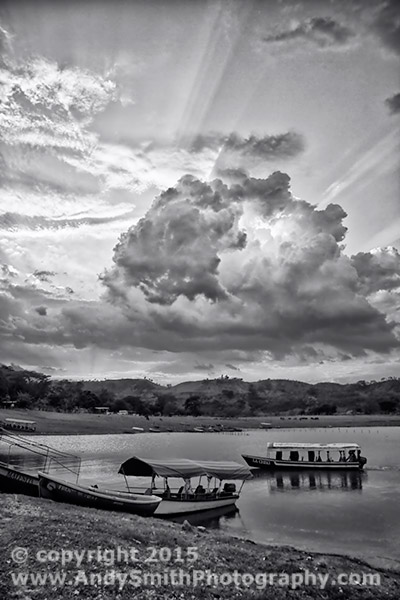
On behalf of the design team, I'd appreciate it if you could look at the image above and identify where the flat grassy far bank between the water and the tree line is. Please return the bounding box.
[0,410,400,435]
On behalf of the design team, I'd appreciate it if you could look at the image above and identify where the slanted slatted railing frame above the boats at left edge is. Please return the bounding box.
[0,428,81,479]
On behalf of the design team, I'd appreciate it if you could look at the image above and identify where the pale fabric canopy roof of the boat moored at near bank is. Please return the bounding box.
[118,456,252,479]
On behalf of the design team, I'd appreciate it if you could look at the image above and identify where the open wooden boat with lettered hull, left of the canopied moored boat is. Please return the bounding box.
[39,472,161,516]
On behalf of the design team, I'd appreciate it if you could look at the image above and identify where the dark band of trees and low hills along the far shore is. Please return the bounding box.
[0,365,400,418]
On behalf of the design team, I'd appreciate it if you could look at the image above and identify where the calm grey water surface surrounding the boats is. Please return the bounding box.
[1,427,400,568]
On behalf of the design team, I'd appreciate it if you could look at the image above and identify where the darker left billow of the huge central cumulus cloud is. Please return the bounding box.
[103,175,246,304]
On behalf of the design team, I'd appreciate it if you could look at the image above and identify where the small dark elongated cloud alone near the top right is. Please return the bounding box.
[263,17,354,48]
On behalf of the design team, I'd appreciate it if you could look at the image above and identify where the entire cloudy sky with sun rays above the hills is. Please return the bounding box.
[0,0,400,384]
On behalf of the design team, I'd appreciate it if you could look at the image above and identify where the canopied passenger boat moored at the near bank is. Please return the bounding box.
[119,456,252,517]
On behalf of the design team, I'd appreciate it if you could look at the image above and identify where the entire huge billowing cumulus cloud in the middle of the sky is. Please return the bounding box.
[97,172,398,357]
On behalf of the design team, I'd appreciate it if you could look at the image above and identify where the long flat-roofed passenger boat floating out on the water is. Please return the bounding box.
[242,442,367,470]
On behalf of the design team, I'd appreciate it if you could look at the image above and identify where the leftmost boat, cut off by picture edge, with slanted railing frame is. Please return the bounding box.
[0,428,80,497]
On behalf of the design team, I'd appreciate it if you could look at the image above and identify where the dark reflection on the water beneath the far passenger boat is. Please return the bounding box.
[252,469,367,492]
